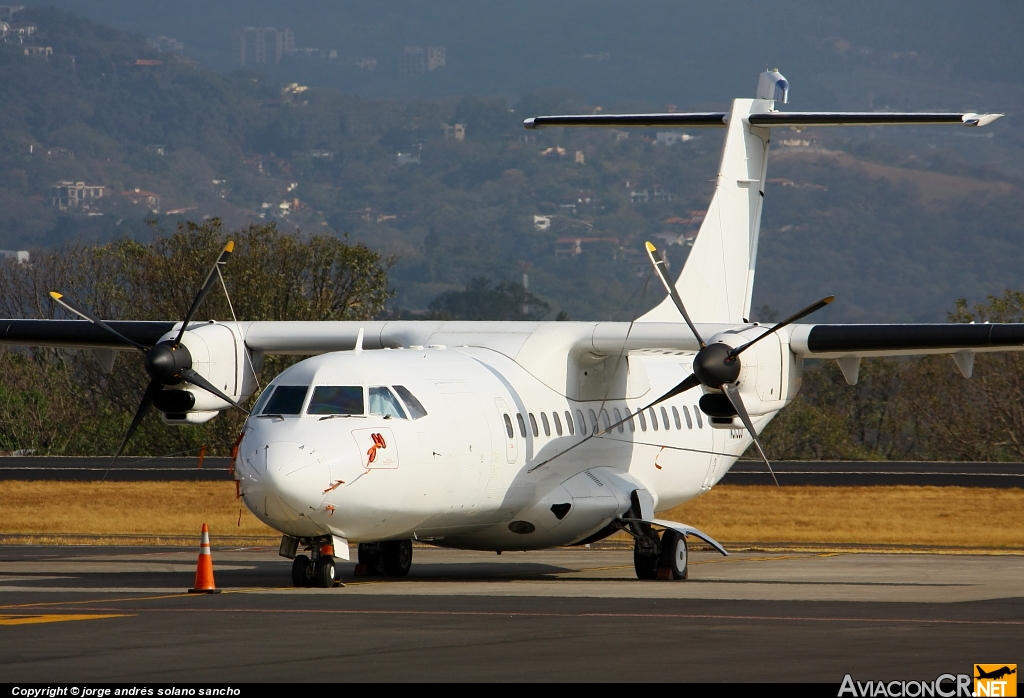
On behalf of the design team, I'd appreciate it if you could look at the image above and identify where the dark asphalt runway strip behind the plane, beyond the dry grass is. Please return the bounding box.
[0,456,1024,487]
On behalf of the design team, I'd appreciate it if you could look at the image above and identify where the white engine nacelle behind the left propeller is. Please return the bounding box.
[155,320,256,425]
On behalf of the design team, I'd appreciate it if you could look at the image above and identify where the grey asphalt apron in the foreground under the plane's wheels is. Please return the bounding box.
[0,547,1024,679]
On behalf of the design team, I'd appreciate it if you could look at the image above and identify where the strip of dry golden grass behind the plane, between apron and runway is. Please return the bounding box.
[0,481,1024,550]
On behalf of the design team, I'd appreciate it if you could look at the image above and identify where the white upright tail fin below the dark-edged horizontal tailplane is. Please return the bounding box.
[639,95,770,322]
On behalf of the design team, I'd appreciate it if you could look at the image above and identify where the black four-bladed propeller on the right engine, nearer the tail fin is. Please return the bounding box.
[647,243,836,487]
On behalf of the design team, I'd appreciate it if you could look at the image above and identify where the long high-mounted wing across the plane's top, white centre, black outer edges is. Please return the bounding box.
[6,319,1024,358]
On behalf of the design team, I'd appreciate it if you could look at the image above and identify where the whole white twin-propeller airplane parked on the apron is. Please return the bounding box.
[0,72,1024,586]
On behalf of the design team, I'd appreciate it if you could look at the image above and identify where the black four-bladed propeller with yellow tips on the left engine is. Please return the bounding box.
[50,241,249,472]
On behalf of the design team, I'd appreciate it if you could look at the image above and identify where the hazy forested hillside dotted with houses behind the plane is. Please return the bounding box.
[0,3,1024,321]
